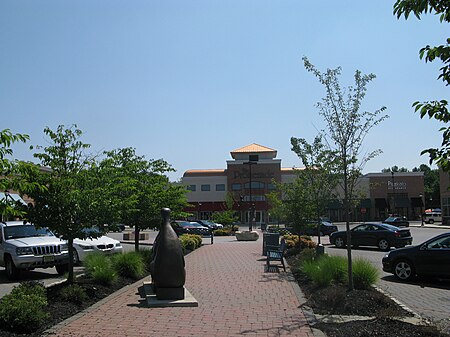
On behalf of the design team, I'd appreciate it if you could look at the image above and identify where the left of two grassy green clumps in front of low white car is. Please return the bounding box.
[84,253,117,285]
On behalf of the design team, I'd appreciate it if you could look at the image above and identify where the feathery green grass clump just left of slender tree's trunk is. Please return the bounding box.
[302,255,347,287]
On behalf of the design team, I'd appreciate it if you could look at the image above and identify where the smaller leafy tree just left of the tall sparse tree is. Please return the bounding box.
[291,135,338,243]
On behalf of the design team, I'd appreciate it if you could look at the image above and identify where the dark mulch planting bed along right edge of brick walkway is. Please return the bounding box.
[288,256,450,337]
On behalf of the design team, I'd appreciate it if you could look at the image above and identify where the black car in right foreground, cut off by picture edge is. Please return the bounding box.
[382,232,450,281]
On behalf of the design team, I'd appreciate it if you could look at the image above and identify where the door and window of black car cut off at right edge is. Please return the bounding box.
[416,235,450,276]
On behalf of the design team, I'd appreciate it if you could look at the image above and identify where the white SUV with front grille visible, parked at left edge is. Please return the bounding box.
[0,221,69,279]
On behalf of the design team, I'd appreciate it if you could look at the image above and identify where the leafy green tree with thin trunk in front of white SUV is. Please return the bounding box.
[29,125,109,283]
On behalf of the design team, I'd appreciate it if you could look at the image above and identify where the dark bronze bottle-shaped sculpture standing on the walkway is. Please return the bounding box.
[150,208,186,300]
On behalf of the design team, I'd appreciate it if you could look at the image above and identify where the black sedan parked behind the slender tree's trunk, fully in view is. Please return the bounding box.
[330,223,412,250]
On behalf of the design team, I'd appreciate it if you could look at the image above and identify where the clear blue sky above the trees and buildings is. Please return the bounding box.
[0,0,449,180]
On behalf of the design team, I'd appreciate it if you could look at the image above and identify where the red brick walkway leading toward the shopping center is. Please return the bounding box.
[44,235,313,337]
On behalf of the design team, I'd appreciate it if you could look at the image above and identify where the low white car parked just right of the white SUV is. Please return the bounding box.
[73,227,123,264]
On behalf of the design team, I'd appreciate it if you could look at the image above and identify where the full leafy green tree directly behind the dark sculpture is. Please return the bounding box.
[99,148,187,251]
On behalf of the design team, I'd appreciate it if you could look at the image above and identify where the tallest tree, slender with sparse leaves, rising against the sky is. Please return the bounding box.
[303,57,388,290]
